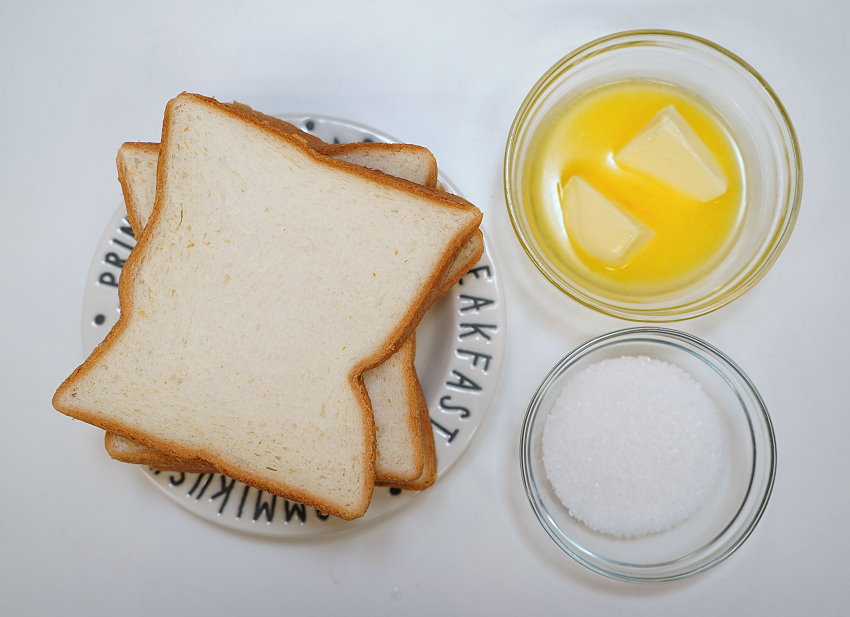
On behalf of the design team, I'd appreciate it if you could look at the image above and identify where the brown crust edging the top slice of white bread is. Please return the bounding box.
[53,93,481,520]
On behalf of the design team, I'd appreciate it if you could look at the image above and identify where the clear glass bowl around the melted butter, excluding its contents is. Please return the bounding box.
[504,31,802,322]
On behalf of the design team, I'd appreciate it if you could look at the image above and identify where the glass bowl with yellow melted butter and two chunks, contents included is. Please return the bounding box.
[504,31,802,322]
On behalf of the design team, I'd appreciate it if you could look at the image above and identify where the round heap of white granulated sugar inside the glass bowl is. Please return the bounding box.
[542,356,724,537]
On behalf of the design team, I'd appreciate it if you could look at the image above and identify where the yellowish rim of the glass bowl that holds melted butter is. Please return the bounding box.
[502,29,803,323]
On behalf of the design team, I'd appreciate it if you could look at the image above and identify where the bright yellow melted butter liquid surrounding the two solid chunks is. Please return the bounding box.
[523,80,744,298]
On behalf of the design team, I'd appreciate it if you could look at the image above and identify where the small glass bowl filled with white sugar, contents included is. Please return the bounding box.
[520,327,776,582]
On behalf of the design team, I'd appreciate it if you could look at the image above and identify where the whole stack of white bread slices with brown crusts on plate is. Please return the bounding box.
[53,93,483,519]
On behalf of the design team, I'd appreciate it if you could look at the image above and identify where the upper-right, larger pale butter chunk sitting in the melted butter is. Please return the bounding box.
[615,105,726,201]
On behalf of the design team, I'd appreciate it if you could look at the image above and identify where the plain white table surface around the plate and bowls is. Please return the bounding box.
[0,0,850,617]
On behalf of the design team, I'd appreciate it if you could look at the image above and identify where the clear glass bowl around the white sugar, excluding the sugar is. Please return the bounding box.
[520,326,776,582]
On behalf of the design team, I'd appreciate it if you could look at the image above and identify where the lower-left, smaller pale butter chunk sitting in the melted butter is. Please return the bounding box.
[561,176,655,266]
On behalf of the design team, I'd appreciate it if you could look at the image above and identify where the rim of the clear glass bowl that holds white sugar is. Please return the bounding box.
[519,326,777,583]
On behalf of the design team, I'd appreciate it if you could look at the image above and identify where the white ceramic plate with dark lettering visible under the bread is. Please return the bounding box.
[83,114,505,536]
